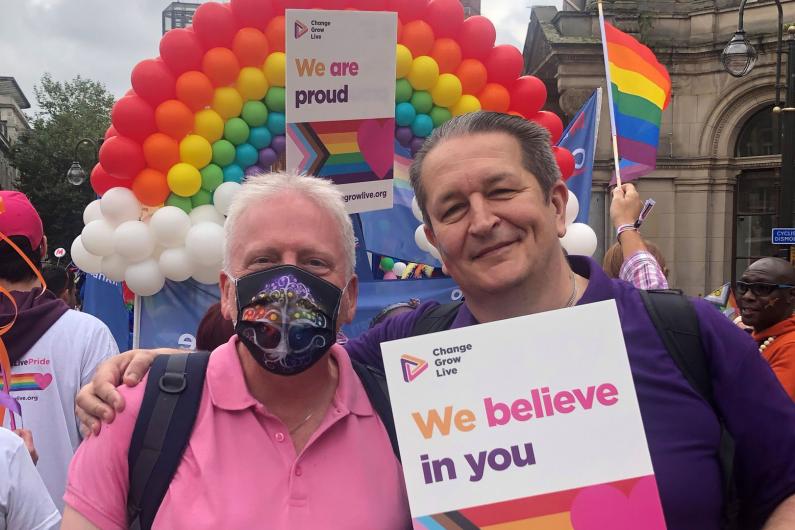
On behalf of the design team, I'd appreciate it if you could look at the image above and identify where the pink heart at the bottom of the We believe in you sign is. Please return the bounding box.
[571,477,665,530]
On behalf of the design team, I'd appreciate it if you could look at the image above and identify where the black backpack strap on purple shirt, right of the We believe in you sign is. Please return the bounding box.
[638,289,739,528]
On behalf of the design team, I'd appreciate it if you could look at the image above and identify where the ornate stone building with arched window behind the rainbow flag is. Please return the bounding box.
[524,0,795,295]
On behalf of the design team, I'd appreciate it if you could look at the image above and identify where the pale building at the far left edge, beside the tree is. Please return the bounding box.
[0,76,30,190]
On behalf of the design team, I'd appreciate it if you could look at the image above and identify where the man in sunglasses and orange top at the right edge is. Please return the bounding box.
[734,258,795,400]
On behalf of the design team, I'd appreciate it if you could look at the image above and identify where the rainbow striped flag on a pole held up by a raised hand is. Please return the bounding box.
[602,22,671,180]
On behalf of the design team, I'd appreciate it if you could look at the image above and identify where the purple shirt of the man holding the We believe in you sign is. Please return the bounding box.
[345,256,795,530]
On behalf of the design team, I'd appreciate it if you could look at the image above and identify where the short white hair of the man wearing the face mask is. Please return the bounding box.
[224,171,356,280]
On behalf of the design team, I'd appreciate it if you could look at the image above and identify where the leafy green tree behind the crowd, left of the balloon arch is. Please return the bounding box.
[11,74,114,255]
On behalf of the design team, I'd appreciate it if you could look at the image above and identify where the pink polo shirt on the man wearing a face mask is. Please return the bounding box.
[64,337,411,530]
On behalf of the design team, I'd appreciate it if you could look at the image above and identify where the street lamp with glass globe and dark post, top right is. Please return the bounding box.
[721,0,795,228]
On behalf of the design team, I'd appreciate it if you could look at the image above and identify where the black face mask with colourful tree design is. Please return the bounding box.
[234,265,342,375]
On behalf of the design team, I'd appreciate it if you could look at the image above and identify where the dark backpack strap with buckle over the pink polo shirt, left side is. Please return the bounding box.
[127,352,210,530]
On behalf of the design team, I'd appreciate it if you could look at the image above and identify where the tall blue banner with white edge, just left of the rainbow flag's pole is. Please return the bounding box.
[558,88,602,224]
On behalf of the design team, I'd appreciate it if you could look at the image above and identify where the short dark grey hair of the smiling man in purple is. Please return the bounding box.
[409,111,560,226]
